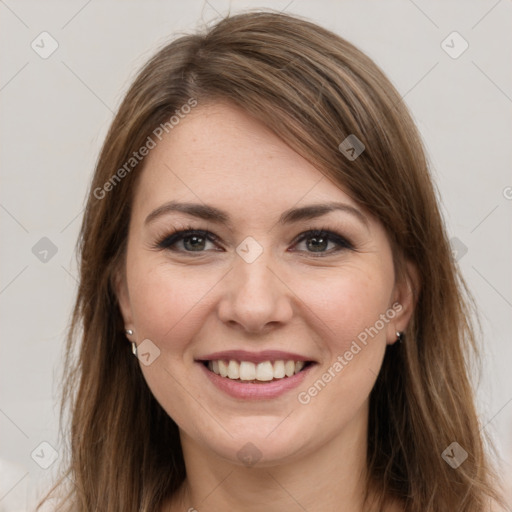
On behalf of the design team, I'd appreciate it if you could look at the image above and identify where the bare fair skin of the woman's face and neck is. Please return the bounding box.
[117,102,415,512]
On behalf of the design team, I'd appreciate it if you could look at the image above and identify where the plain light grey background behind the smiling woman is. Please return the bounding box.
[0,0,512,512]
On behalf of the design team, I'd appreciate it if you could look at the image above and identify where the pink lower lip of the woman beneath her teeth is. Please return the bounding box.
[197,363,314,400]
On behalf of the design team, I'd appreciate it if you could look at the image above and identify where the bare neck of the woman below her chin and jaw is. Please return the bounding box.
[166,407,384,512]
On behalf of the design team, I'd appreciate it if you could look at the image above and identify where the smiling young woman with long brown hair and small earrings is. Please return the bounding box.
[37,9,504,512]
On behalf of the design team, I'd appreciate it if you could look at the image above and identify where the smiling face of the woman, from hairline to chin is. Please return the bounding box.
[118,99,412,464]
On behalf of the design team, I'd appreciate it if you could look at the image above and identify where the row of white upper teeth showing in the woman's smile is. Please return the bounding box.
[208,359,305,381]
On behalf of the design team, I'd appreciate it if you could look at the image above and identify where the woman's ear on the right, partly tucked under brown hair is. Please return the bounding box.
[386,261,421,345]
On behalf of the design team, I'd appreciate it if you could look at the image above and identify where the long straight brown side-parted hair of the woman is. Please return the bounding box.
[38,12,497,512]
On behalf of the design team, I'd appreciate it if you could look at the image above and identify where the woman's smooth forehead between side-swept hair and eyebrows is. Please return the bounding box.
[134,102,362,218]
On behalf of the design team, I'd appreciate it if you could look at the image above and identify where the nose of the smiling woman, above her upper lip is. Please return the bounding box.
[218,252,293,334]
